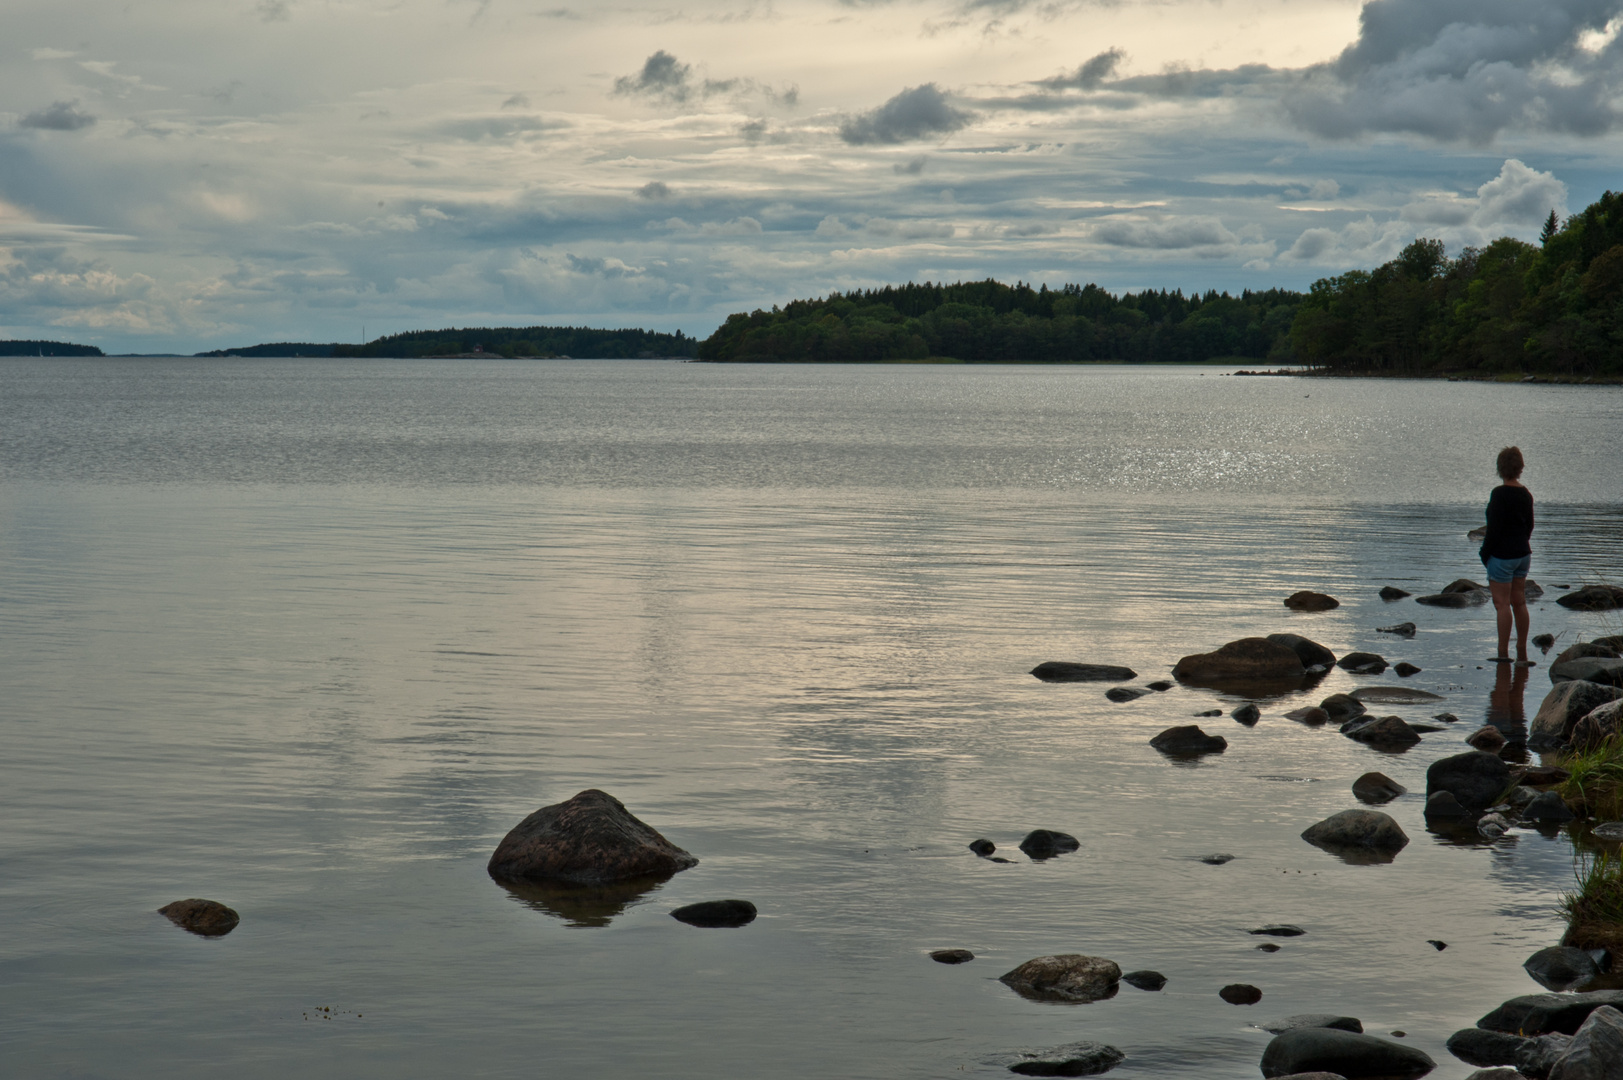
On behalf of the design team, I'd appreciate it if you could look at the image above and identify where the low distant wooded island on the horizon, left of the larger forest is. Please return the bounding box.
[333,326,698,361]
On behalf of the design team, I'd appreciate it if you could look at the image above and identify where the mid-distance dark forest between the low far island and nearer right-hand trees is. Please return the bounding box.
[698,279,1302,364]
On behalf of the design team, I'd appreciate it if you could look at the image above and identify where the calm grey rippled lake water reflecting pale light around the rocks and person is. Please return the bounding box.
[0,359,1623,1080]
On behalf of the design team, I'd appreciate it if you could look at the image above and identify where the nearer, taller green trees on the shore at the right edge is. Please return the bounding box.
[1290,192,1623,377]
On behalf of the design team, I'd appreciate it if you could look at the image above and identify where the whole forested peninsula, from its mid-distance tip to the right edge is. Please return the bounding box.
[700,181,1623,378]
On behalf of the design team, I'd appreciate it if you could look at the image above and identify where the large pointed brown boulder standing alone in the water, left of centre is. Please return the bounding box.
[485,788,698,885]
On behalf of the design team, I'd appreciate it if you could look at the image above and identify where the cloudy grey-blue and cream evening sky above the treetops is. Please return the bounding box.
[0,0,1623,352]
